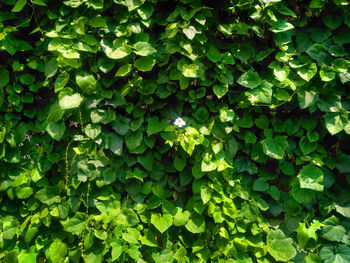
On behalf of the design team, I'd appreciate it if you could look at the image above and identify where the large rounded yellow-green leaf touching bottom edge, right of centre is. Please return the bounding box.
[267,230,297,262]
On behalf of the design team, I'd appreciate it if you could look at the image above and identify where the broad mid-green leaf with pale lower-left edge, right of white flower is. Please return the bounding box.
[261,136,288,159]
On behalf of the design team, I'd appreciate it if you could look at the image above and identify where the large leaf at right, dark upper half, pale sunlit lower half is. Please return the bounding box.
[298,164,324,191]
